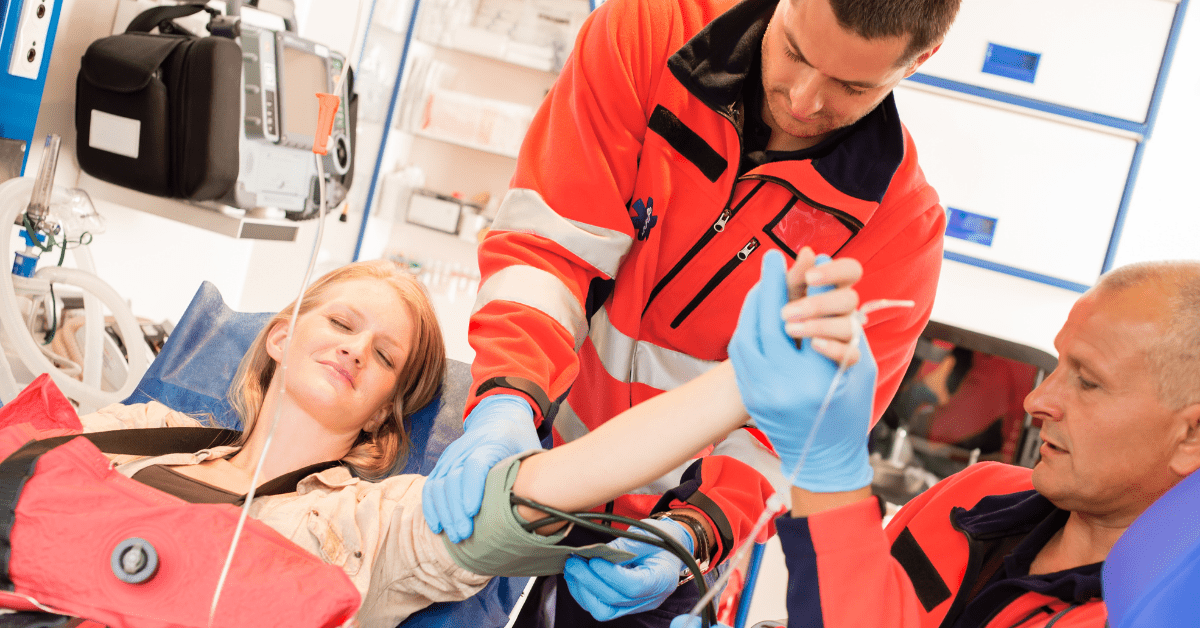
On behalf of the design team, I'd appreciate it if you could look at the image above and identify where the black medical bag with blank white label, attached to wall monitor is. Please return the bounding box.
[76,5,242,201]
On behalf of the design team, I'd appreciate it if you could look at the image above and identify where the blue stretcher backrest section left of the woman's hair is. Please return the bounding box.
[125,281,274,429]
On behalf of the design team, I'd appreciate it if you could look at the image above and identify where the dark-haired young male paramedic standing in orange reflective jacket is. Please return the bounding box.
[424,0,959,626]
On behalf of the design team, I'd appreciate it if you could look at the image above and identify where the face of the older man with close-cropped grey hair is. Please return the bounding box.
[1025,282,1186,525]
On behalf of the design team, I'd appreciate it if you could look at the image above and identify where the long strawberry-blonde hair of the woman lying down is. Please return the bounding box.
[229,259,446,479]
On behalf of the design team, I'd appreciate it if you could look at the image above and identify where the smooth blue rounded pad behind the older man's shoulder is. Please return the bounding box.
[1103,473,1200,628]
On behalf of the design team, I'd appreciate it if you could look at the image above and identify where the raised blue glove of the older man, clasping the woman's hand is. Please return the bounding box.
[730,251,876,492]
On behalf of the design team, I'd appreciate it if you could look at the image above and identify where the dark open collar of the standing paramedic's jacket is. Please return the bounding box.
[667,0,905,204]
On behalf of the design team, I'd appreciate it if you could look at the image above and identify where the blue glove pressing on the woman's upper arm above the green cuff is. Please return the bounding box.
[421,395,541,543]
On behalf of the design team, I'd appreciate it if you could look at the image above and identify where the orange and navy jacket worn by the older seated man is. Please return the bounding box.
[776,462,1108,628]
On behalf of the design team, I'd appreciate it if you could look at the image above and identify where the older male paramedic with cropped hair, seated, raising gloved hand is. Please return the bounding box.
[686,261,1200,628]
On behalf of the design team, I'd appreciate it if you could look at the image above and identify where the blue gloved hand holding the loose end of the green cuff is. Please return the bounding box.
[563,519,695,622]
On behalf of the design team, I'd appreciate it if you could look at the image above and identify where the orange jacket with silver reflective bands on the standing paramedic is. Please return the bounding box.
[467,0,946,557]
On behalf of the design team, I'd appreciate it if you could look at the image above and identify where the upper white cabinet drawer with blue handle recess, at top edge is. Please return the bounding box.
[919,0,1178,122]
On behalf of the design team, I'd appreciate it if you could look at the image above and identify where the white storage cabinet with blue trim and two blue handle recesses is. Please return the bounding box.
[895,0,1184,292]
